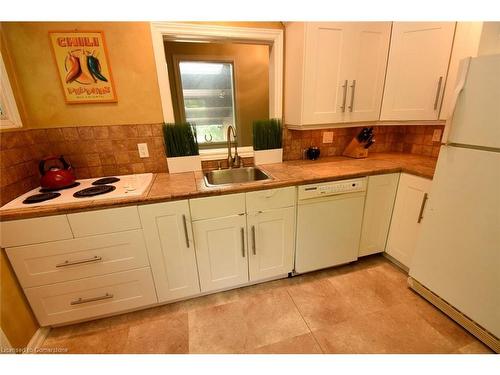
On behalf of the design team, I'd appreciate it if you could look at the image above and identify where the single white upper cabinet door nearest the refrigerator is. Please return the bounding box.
[380,22,455,120]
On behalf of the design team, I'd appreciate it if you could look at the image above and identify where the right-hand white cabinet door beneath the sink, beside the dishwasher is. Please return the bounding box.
[247,207,295,281]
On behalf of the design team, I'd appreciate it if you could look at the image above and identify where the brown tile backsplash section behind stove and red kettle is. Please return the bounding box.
[0,124,168,205]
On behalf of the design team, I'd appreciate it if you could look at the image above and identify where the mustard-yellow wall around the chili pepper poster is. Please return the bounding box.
[1,22,163,128]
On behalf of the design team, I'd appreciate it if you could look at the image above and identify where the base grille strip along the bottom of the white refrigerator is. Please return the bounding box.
[408,277,500,353]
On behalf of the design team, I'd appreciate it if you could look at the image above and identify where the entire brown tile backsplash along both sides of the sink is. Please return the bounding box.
[0,124,443,205]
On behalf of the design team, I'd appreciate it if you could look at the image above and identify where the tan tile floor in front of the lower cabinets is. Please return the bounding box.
[44,255,491,353]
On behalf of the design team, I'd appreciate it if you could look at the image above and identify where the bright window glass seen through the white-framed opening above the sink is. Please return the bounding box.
[179,61,236,147]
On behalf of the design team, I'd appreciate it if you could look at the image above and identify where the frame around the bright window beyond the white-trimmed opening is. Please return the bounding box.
[172,55,240,150]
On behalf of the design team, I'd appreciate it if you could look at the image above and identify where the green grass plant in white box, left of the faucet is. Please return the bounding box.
[163,122,201,173]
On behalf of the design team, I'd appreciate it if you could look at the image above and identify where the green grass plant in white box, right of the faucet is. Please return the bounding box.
[253,119,283,165]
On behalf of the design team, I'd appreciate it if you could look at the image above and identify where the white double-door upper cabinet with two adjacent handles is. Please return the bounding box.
[285,22,391,127]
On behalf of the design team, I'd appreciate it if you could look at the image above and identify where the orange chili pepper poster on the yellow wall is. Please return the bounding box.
[49,31,117,104]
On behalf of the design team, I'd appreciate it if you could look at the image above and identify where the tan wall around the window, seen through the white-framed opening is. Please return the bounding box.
[165,42,269,146]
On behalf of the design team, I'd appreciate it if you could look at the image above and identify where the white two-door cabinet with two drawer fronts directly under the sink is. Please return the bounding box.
[190,187,296,292]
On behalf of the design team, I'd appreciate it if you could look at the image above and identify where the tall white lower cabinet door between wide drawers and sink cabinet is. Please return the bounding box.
[139,201,200,302]
